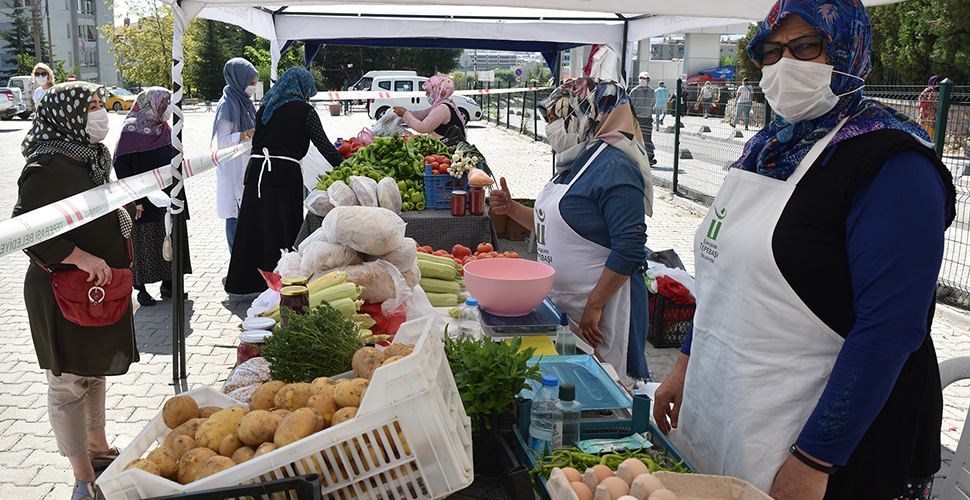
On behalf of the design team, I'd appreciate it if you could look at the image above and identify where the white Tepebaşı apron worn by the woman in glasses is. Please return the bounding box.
[670,122,844,492]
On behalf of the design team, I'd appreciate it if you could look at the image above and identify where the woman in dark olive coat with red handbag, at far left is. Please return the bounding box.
[13,82,138,500]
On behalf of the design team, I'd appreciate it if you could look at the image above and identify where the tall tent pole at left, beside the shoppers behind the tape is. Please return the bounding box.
[169,0,188,394]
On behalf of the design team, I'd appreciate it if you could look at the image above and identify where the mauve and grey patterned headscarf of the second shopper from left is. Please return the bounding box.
[114,87,172,160]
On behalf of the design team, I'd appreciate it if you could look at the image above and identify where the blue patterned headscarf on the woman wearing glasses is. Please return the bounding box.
[732,0,930,180]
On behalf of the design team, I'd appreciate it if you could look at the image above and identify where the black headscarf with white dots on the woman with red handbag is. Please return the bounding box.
[20,82,131,238]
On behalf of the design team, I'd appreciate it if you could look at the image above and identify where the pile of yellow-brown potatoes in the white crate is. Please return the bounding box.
[124,344,414,484]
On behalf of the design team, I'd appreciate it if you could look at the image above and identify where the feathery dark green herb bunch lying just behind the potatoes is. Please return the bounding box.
[260,302,364,383]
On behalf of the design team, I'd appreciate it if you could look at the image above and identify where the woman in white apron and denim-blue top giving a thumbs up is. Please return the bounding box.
[490,78,653,382]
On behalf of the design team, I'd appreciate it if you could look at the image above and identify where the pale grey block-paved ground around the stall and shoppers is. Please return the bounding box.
[0,104,970,500]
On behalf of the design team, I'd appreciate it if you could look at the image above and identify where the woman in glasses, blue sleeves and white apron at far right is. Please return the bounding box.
[654,0,955,500]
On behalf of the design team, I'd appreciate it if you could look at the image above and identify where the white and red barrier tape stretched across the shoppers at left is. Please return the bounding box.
[0,142,252,257]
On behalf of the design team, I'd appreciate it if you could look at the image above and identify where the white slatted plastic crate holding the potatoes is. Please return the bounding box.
[98,316,474,500]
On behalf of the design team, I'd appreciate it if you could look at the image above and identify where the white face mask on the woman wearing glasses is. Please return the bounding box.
[761,57,865,123]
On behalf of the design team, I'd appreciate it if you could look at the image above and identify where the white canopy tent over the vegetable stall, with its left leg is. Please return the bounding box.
[151,0,899,386]
